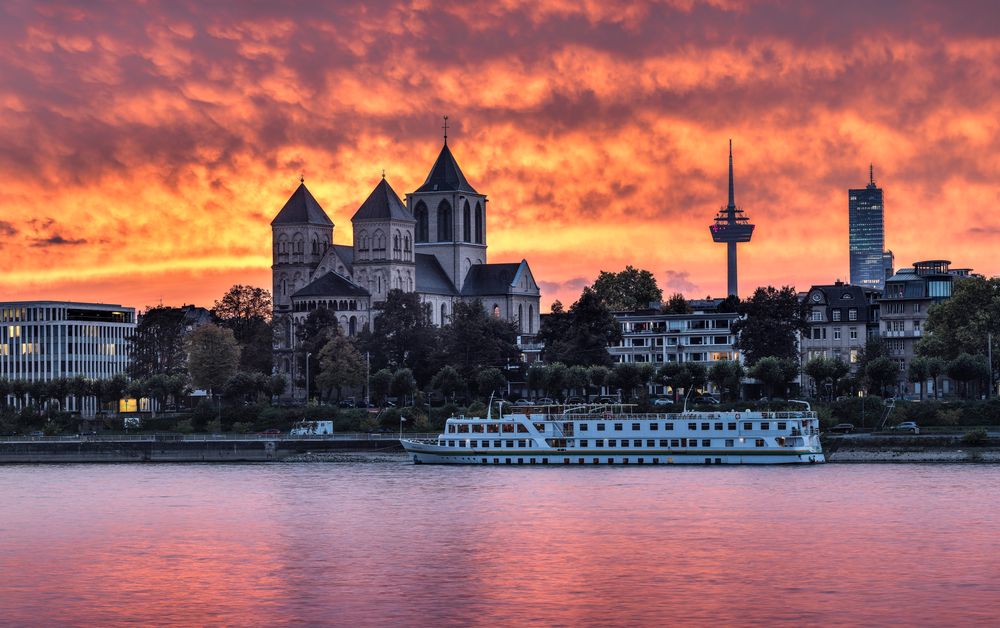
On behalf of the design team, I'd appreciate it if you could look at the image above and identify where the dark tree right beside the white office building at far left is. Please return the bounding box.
[129,306,187,379]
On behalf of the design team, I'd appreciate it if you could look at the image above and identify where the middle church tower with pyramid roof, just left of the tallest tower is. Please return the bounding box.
[351,174,416,303]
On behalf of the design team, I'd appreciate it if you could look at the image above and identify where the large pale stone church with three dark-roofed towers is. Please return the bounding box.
[271,127,541,379]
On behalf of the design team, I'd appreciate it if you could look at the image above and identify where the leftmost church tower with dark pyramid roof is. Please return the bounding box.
[271,179,333,315]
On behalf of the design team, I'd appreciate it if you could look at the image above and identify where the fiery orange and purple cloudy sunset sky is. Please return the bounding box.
[0,0,1000,309]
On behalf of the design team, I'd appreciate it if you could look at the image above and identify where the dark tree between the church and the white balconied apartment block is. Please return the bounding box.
[539,287,621,366]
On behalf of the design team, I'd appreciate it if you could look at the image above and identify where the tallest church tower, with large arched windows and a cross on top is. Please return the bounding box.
[406,116,486,291]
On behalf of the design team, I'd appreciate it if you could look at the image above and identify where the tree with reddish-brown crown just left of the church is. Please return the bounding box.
[212,284,274,373]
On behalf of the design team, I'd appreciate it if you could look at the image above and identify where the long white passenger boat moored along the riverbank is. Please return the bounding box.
[401,404,826,465]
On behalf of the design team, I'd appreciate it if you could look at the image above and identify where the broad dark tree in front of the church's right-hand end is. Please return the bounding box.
[440,299,520,381]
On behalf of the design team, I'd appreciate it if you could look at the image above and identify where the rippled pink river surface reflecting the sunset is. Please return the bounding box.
[0,458,1000,625]
